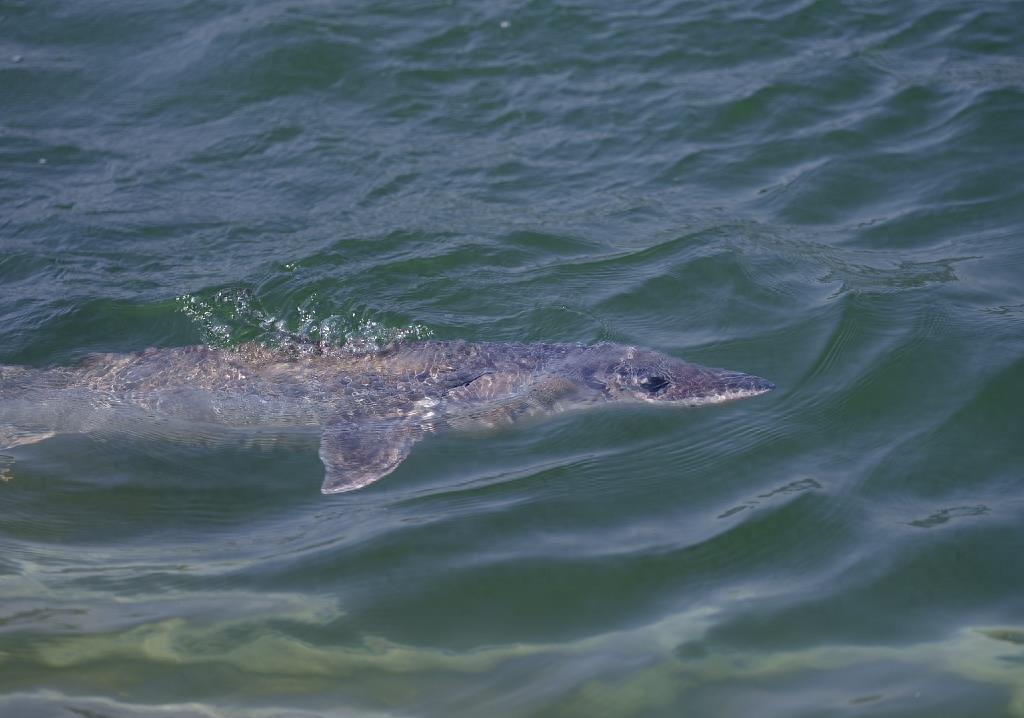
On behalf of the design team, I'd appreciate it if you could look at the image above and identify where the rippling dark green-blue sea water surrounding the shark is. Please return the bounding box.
[0,0,1024,717]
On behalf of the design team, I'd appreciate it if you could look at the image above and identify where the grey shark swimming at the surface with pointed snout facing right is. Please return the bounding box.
[0,341,774,494]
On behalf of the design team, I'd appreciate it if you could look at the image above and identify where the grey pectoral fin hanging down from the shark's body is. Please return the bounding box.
[319,421,422,494]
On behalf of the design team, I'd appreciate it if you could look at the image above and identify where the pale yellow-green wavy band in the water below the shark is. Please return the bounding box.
[19,600,1024,716]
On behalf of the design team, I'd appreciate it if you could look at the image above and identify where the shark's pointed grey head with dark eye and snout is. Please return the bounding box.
[584,344,775,407]
